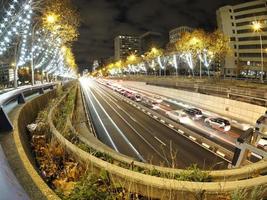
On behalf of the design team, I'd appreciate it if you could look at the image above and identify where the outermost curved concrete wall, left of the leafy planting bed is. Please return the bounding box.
[13,90,59,200]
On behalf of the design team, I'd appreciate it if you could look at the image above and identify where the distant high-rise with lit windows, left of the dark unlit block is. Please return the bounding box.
[114,35,140,61]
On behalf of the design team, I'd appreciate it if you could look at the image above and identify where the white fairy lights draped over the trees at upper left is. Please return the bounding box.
[0,0,75,80]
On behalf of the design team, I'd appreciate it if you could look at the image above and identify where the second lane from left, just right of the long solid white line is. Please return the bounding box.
[90,85,166,165]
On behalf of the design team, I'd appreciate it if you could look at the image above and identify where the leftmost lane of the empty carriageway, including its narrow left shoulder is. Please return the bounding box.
[82,85,139,159]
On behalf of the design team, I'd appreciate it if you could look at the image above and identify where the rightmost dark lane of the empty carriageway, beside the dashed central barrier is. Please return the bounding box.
[96,82,228,169]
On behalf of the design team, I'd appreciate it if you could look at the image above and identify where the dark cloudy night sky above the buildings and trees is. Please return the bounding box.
[73,0,246,69]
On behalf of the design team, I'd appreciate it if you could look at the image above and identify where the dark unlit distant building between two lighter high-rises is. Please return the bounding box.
[140,31,165,54]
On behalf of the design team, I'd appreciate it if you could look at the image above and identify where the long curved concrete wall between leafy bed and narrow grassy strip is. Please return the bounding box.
[48,93,267,200]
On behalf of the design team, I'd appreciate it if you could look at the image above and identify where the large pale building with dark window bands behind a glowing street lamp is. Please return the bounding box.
[216,0,267,76]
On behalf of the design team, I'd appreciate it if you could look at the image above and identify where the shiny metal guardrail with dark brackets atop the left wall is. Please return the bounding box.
[0,83,56,132]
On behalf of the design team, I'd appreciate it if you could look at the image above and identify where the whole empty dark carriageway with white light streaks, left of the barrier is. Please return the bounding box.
[81,79,228,169]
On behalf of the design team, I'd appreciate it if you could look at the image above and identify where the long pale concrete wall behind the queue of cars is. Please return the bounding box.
[122,82,267,125]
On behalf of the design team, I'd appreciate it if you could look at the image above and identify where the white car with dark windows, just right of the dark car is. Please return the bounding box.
[204,117,231,132]
